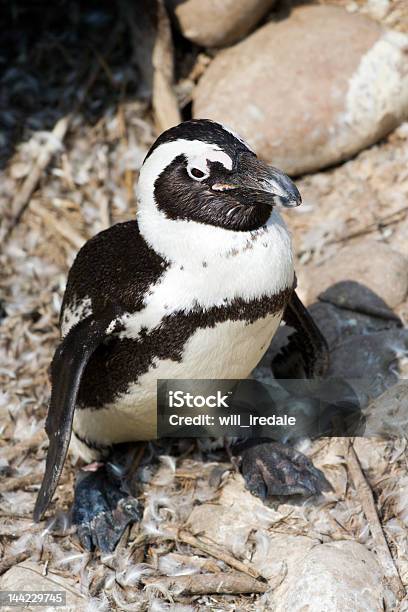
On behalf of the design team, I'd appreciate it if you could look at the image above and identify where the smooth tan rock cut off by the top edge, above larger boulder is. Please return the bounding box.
[167,0,275,47]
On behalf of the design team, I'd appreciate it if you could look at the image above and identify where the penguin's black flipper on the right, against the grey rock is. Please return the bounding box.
[272,291,329,379]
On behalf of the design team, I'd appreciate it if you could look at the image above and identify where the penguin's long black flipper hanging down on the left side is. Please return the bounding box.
[33,313,119,521]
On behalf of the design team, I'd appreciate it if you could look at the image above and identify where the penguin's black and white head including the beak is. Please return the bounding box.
[138,119,301,231]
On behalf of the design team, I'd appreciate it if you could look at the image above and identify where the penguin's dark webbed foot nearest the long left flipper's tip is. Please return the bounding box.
[72,464,141,552]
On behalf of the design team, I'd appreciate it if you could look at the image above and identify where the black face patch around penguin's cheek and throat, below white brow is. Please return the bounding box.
[154,150,271,232]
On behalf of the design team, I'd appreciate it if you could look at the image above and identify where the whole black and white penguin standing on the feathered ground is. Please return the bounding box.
[34,119,328,550]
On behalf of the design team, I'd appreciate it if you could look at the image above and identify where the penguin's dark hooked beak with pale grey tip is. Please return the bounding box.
[211,154,302,208]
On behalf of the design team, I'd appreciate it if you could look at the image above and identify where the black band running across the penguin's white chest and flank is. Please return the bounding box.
[78,287,293,408]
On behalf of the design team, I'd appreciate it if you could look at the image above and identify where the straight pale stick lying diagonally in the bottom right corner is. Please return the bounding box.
[347,443,405,600]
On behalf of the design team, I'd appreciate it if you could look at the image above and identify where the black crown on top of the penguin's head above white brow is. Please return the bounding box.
[145,119,253,161]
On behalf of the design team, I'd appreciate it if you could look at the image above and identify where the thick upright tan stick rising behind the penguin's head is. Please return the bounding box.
[152,0,181,132]
